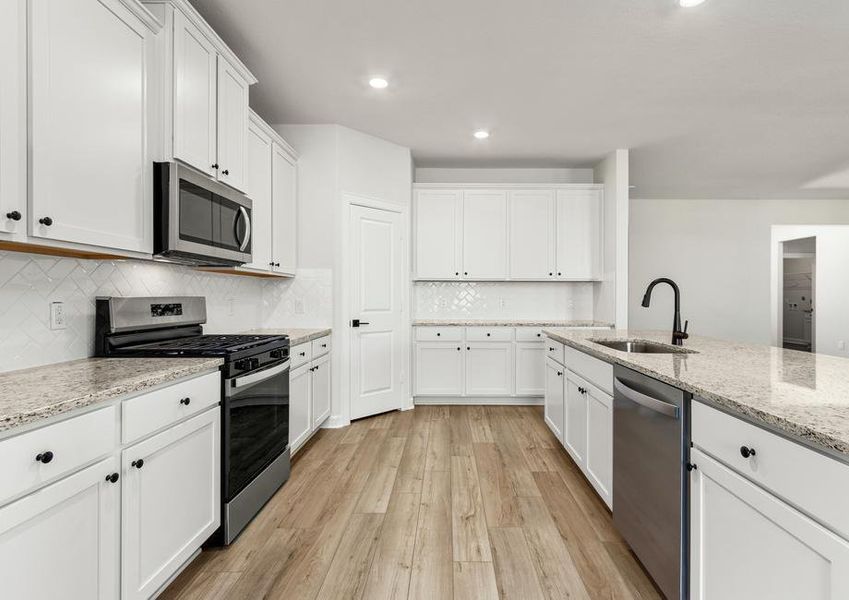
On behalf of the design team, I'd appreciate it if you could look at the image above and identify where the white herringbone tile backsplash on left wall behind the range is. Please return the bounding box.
[0,252,332,371]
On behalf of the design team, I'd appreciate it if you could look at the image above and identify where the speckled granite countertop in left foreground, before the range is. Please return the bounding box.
[0,358,223,433]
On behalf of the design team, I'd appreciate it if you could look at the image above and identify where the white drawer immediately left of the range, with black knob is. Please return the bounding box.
[121,372,221,444]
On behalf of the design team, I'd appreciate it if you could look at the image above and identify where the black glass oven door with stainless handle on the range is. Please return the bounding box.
[222,360,289,502]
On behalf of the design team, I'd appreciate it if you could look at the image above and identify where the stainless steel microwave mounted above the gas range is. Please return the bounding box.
[153,162,252,266]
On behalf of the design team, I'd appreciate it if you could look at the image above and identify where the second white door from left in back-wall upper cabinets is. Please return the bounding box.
[463,190,507,279]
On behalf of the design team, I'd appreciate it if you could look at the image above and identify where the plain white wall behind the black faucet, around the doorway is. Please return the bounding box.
[629,200,849,344]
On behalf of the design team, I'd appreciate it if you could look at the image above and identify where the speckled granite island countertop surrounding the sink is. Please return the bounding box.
[545,329,849,460]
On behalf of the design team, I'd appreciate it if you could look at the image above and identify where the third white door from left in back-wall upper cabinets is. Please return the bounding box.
[510,190,556,279]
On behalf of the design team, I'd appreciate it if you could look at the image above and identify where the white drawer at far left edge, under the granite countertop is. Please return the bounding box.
[0,406,118,504]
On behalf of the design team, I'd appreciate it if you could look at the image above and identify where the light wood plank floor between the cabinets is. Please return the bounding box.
[161,406,660,600]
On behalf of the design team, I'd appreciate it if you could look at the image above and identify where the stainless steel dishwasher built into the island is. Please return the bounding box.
[613,365,692,600]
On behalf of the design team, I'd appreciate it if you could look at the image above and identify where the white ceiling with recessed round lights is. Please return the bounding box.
[193,0,849,198]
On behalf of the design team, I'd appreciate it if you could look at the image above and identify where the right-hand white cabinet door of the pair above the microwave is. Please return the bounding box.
[217,54,249,191]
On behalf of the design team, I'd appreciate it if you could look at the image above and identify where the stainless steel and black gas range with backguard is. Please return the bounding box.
[95,296,289,544]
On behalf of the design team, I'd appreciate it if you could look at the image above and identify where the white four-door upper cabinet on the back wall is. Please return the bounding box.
[414,184,603,281]
